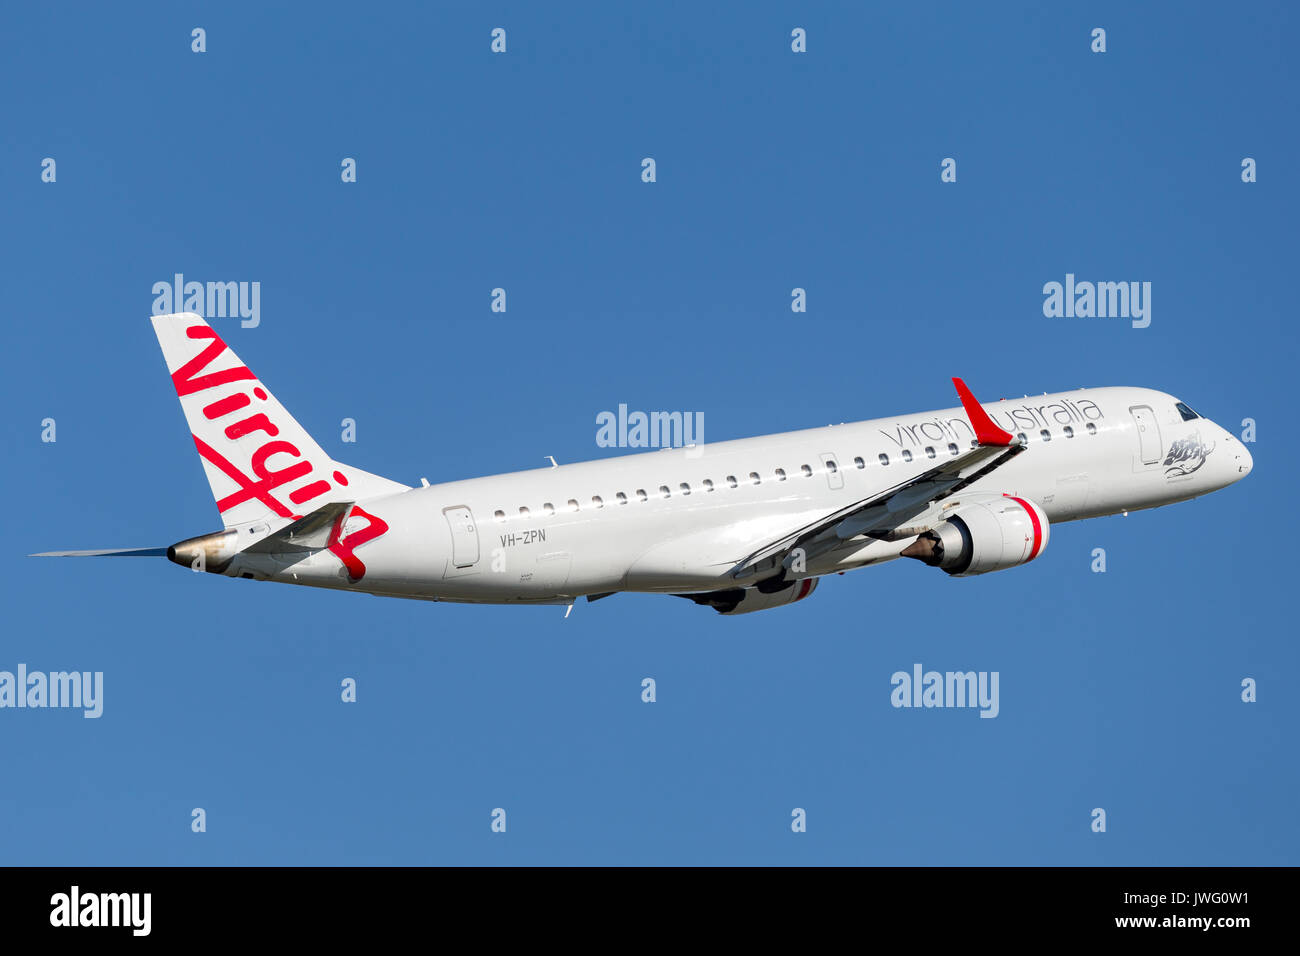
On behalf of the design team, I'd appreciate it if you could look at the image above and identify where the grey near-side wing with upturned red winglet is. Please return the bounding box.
[731,378,1026,579]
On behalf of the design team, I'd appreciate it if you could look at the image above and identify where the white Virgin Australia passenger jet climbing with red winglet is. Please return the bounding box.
[36,312,1253,617]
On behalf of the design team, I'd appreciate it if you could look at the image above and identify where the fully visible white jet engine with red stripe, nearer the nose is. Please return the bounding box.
[900,494,1050,578]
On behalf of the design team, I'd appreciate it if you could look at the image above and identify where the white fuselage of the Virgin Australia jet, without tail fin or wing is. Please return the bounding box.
[233,388,1251,604]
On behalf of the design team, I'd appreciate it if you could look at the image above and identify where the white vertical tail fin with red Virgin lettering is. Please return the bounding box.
[152,312,410,528]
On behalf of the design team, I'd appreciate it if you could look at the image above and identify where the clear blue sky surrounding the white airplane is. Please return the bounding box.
[0,3,1300,865]
